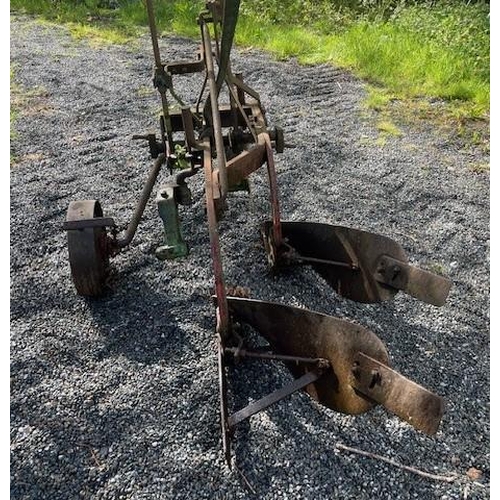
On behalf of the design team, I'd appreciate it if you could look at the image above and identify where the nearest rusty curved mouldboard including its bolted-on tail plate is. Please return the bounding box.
[228,297,444,434]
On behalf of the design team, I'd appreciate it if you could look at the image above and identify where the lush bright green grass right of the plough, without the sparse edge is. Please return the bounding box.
[237,6,490,118]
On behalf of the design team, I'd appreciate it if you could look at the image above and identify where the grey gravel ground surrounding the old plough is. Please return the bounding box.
[10,18,490,500]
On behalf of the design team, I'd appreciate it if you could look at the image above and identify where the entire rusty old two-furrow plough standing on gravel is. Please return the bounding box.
[63,0,451,464]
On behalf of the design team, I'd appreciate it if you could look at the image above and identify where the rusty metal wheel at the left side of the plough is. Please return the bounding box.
[66,200,109,297]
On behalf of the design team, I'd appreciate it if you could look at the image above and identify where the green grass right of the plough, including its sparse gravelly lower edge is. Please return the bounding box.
[237,0,490,143]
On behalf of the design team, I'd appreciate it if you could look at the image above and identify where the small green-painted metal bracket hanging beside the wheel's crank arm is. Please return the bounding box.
[155,186,189,260]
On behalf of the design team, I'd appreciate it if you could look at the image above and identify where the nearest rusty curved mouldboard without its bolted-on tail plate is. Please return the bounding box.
[227,297,389,414]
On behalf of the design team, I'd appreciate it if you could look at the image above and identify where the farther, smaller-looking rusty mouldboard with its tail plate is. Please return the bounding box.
[263,221,451,306]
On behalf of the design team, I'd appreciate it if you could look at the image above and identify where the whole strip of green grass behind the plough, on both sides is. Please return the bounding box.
[11,0,490,129]
